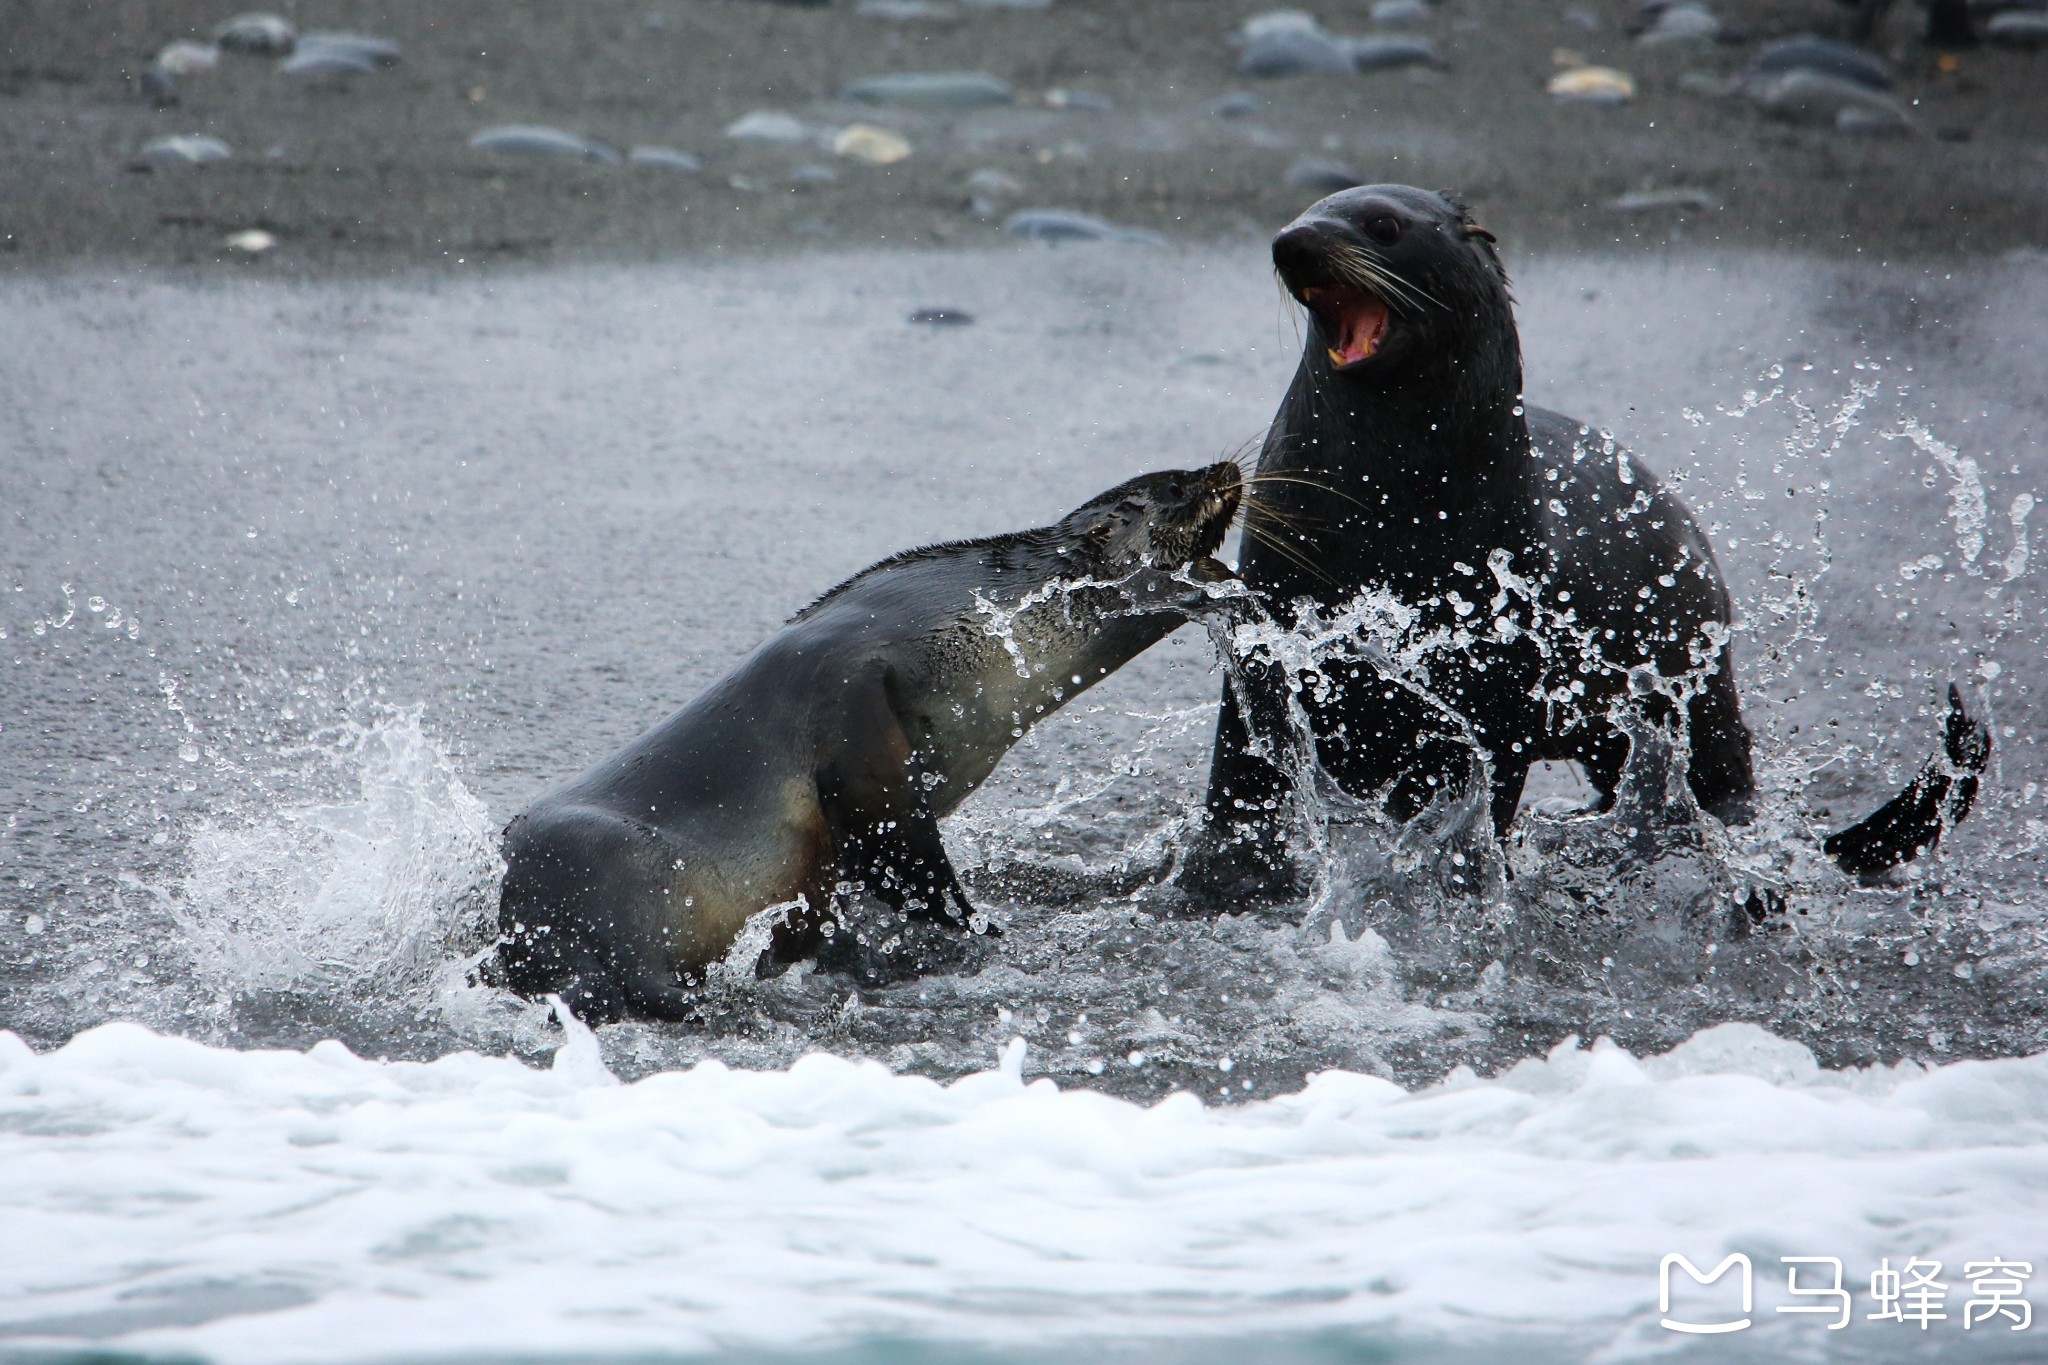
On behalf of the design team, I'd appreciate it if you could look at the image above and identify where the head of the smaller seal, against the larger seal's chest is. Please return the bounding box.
[1055,460,1245,577]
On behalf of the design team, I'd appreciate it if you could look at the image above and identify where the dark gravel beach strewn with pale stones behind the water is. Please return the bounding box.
[0,0,2048,274]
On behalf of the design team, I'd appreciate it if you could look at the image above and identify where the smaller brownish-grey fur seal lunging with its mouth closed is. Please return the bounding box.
[498,463,1243,1019]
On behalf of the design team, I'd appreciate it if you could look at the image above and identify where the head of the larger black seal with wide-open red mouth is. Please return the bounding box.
[1274,184,1520,383]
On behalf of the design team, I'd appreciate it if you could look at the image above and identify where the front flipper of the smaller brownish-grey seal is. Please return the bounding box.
[817,675,973,923]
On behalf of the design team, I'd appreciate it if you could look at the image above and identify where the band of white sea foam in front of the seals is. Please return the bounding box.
[0,1023,2048,1363]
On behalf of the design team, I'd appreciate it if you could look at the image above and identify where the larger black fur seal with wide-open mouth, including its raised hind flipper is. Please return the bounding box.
[1182,184,1989,900]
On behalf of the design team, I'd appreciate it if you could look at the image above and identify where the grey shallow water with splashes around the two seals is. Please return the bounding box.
[0,248,2048,1097]
